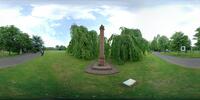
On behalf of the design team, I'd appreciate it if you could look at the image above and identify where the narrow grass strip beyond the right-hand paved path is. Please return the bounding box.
[161,51,200,58]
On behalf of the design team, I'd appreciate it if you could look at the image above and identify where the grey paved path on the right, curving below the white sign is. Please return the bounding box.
[153,52,200,68]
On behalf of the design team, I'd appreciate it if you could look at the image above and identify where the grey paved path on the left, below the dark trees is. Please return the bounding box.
[0,53,40,68]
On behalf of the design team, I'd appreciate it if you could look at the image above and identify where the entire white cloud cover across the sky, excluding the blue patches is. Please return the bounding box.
[0,4,200,46]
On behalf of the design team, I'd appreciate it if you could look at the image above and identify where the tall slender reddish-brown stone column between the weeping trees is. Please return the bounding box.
[99,25,105,66]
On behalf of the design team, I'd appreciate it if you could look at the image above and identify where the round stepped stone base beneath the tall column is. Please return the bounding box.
[85,62,119,75]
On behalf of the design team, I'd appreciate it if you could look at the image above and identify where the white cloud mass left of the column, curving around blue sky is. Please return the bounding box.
[0,5,96,46]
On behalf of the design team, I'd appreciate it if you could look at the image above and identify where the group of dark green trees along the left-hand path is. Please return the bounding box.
[0,25,44,54]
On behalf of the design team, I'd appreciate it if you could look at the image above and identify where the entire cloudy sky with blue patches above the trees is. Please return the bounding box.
[0,0,200,47]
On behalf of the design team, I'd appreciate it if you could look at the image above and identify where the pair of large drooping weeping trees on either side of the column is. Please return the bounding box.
[67,25,150,64]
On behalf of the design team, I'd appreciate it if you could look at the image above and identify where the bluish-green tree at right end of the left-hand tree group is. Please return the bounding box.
[32,35,44,52]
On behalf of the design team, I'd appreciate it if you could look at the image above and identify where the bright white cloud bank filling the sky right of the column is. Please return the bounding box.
[99,5,200,43]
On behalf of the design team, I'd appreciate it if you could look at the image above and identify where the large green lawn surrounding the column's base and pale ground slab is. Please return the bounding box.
[0,51,200,100]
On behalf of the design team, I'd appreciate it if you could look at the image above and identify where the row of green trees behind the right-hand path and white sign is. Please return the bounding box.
[150,28,200,52]
